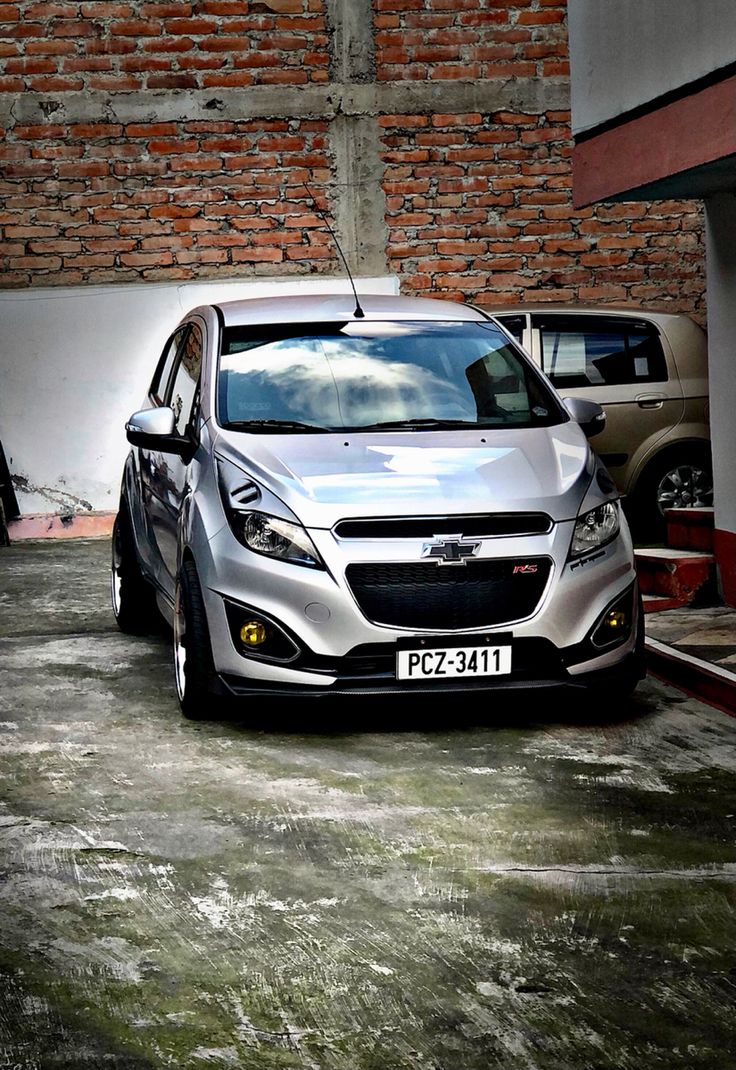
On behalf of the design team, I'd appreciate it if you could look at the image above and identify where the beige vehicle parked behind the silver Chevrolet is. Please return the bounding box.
[486,305,712,539]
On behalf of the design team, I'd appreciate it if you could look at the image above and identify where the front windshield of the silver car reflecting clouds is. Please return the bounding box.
[217,320,567,433]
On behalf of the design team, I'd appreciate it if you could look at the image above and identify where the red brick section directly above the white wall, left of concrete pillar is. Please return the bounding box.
[0,120,335,286]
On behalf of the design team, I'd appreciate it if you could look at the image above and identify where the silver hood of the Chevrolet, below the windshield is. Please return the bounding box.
[215,422,595,528]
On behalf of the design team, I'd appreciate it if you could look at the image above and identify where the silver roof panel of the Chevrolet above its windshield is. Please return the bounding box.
[212,293,488,327]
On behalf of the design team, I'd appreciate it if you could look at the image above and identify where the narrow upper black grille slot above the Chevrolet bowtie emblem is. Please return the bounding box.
[335,513,552,539]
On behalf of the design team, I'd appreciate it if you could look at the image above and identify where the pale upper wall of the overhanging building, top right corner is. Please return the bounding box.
[568,0,736,134]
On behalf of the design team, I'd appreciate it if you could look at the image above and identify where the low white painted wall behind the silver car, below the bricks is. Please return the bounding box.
[0,276,399,514]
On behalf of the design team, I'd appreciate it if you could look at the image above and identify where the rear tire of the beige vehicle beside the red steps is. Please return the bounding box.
[627,444,712,542]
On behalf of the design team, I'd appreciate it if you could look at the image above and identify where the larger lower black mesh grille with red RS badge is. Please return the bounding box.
[346,557,552,631]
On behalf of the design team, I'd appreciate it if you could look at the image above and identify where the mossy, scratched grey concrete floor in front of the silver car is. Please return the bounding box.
[0,541,736,1070]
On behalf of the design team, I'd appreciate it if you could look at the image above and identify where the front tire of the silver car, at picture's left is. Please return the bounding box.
[173,560,217,721]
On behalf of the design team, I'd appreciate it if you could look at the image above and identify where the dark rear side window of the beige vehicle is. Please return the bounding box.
[533,316,668,388]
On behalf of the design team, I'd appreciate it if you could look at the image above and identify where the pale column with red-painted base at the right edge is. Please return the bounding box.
[705,194,736,606]
